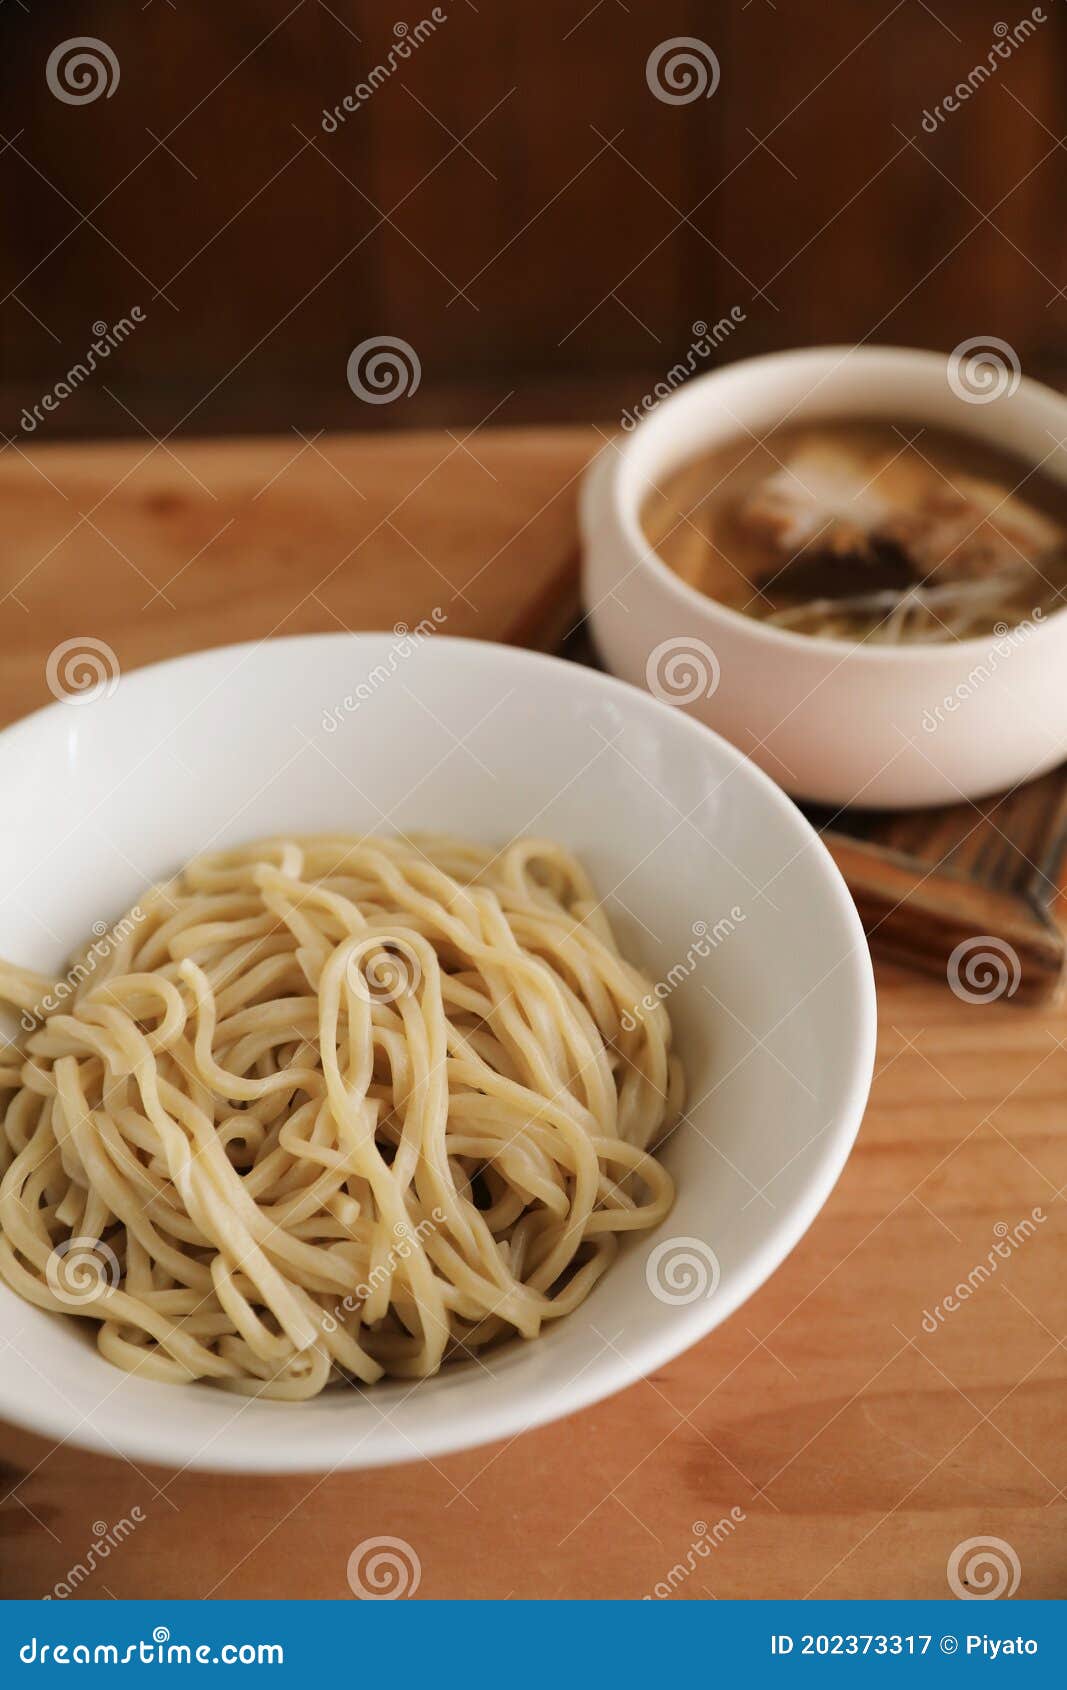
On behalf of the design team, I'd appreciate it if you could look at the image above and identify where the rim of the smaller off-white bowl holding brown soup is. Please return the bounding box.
[598,345,1067,666]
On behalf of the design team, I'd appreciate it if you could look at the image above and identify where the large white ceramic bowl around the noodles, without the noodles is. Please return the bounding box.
[0,634,876,1472]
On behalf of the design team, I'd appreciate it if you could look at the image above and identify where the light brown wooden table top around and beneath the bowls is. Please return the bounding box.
[0,429,1067,1599]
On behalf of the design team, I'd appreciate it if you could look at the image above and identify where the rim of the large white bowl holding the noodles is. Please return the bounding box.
[0,630,878,1474]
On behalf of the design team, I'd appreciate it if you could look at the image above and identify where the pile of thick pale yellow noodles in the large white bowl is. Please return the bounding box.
[0,837,681,1399]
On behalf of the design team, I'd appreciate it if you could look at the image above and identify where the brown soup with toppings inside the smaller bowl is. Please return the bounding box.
[641,419,1067,644]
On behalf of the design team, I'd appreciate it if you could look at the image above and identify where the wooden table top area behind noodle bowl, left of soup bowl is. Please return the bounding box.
[0,429,599,720]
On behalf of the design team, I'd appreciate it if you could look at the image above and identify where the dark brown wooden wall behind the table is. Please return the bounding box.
[0,0,1067,439]
